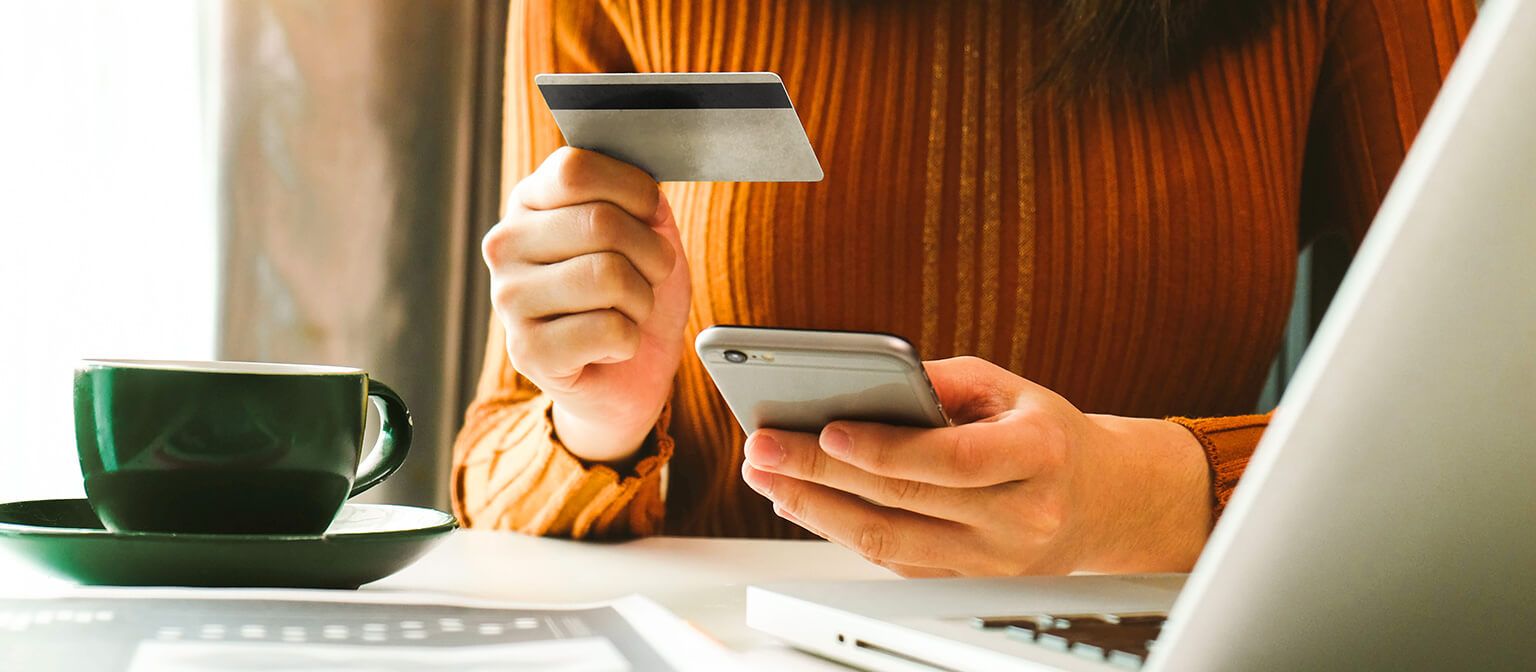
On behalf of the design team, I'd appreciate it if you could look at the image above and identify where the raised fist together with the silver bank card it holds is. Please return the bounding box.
[482,72,822,462]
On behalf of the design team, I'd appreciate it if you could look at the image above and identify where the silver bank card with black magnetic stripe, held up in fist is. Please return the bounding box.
[533,72,822,183]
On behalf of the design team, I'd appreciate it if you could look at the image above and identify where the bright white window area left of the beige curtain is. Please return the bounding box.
[0,0,218,500]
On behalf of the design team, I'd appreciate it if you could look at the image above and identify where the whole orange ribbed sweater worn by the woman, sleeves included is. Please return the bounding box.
[452,0,1475,537]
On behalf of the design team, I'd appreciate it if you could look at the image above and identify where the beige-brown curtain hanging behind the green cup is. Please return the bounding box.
[212,0,505,506]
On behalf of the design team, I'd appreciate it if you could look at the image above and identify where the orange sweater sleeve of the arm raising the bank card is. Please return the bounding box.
[450,0,673,539]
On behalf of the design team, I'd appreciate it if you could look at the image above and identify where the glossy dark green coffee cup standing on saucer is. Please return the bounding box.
[75,359,410,534]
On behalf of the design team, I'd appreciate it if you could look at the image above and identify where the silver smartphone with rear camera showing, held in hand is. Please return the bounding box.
[694,325,949,434]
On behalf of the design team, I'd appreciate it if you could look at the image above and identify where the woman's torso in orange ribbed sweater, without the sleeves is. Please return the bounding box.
[586,0,1322,535]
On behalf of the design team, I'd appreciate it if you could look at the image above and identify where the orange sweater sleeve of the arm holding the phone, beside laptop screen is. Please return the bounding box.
[1169,0,1476,517]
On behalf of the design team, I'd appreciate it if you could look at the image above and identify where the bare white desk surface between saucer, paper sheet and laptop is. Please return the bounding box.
[371,529,897,670]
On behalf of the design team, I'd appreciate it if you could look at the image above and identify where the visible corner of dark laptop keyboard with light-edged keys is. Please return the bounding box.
[971,614,1167,669]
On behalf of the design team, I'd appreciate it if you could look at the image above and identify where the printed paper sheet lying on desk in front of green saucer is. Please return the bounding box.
[0,588,737,672]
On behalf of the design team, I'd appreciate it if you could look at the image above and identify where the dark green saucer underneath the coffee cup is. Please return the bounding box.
[0,499,458,588]
